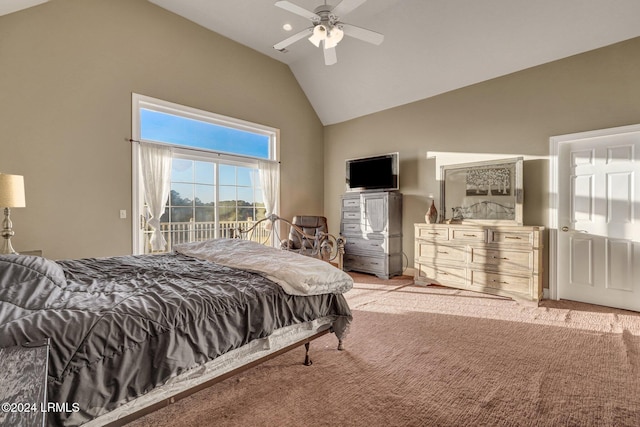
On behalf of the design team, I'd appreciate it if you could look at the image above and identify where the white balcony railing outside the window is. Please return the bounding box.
[144,221,269,252]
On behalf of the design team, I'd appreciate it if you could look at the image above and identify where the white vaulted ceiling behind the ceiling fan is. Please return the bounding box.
[6,0,640,125]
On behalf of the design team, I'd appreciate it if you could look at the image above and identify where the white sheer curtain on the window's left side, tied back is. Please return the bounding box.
[140,142,172,252]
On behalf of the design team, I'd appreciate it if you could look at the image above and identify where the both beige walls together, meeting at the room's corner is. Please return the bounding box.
[0,0,640,264]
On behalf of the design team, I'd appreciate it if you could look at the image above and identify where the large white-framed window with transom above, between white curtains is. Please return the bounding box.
[133,94,277,253]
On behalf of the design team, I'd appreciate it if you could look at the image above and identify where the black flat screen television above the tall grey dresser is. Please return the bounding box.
[347,153,400,191]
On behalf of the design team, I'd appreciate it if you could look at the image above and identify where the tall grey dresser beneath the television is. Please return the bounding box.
[340,191,402,279]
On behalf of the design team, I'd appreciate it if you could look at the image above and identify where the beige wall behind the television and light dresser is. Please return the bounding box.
[324,38,640,280]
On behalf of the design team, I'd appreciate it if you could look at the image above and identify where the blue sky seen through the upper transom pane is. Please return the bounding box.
[140,108,270,159]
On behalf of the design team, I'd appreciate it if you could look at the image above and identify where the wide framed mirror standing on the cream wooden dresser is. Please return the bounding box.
[440,157,524,225]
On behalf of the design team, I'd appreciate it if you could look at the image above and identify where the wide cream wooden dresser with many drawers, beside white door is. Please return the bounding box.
[414,224,544,302]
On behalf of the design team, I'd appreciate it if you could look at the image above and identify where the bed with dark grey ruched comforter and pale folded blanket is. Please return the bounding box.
[0,239,352,425]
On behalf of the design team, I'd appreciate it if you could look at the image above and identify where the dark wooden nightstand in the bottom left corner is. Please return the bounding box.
[0,340,49,427]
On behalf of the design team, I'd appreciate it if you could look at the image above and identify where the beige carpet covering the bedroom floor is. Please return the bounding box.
[131,274,640,427]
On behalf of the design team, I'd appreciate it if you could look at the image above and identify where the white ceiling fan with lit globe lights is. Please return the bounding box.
[273,0,384,65]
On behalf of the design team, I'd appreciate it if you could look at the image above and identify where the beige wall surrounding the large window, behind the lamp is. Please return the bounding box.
[0,0,323,259]
